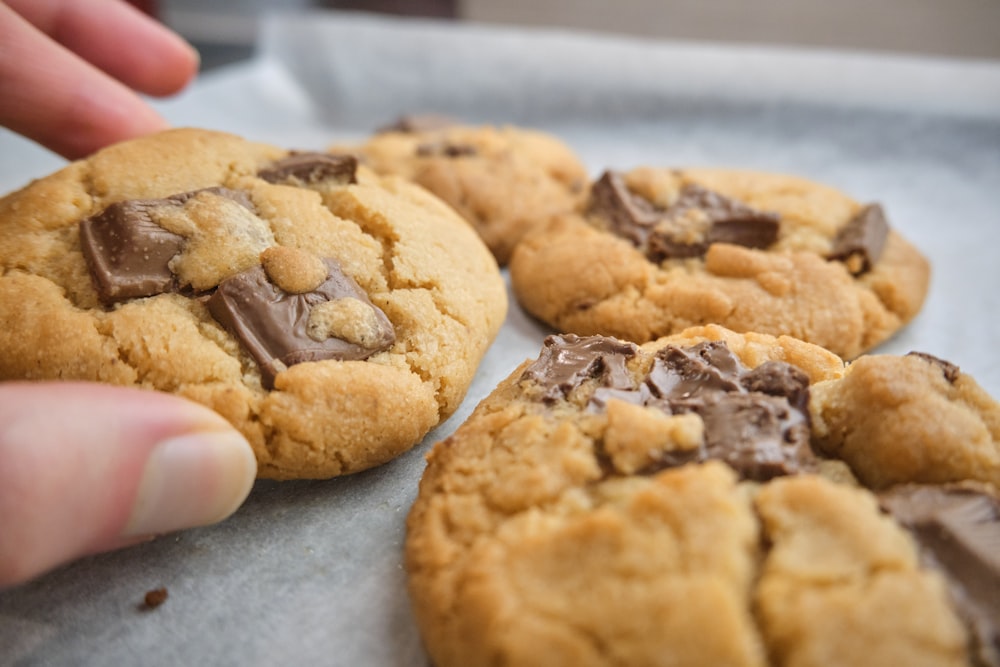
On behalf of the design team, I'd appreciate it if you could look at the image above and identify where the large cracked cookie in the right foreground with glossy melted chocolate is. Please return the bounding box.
[406,326,1000,667]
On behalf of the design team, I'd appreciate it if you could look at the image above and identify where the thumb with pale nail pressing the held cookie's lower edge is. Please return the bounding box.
[0,383,257,587]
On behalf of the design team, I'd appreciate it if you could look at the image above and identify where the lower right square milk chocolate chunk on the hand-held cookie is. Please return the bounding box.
[208,259,395,389]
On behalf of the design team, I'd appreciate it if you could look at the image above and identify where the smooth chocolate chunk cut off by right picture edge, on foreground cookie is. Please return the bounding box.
[880,484,1000,667]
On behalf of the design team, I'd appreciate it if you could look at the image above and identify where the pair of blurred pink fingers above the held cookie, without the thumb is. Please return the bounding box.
[0,0,198,159]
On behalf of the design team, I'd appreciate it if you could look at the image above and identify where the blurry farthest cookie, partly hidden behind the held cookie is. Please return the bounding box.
[346,116,588,265]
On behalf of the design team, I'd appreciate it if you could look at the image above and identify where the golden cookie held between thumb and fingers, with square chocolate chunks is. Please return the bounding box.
[0,129,506,479]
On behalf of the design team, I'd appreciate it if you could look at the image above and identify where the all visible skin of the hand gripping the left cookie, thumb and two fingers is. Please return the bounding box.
[0,0,257,589]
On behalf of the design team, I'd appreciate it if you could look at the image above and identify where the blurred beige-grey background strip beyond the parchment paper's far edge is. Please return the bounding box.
[148,0,1000,69]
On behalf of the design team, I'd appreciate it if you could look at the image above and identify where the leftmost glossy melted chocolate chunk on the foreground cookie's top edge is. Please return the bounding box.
[521,334,638,403]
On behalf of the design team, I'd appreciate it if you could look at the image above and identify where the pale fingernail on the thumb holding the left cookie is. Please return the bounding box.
[123,429,257,537]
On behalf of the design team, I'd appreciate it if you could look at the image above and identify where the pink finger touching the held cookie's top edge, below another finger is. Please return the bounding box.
[0,2,167,159]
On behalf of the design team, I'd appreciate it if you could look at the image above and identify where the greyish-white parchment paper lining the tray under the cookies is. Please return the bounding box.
[0,13,1000,666]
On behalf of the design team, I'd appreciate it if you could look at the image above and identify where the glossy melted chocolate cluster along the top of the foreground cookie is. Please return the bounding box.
[522,336,818,480]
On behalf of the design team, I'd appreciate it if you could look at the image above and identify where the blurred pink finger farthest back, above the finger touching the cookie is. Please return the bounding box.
[7,0,198,95]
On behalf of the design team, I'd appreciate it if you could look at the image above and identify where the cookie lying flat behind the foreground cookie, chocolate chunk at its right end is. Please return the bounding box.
[510,168,930,358]
